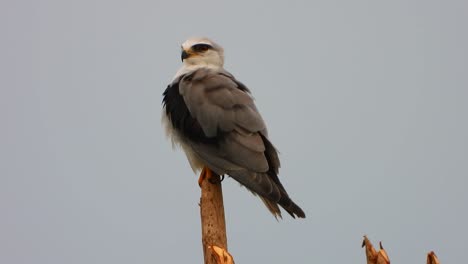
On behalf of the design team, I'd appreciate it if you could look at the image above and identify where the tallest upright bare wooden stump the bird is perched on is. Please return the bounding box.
[200,175,233,264]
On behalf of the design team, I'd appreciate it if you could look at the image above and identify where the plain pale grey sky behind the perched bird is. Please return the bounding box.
[0,0,468,264]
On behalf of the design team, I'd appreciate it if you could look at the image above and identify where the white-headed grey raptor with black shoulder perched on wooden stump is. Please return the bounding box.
[162,37,305,219]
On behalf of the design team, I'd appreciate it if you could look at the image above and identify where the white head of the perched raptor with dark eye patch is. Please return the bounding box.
[181,38,224,68]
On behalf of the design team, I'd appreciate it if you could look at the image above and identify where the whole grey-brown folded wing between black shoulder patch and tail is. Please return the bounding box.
[179,69,269,173]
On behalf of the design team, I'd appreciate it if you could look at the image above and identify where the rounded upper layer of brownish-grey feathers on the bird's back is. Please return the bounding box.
[179,69,266,137]
